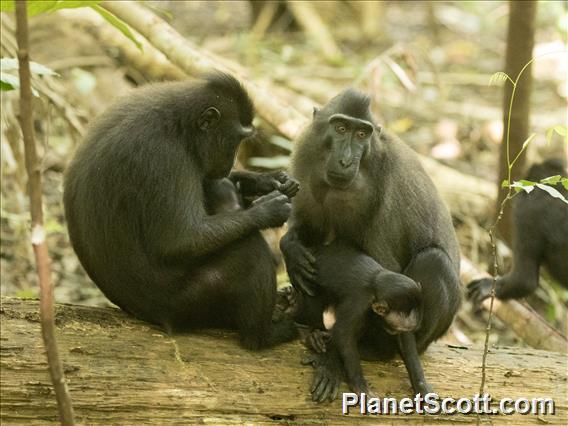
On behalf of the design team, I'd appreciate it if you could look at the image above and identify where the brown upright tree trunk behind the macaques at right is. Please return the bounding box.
[496,0,537,244]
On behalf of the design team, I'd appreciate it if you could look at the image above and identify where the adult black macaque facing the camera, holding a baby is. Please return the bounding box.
[280,89,461,401]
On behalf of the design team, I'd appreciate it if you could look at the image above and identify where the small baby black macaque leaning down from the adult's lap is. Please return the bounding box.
[296,240,422,401]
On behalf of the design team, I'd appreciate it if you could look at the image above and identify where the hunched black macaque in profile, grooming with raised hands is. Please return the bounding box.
[64,74,298,349]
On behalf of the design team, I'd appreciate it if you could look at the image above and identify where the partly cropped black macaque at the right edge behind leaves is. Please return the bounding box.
[468,159,568,304]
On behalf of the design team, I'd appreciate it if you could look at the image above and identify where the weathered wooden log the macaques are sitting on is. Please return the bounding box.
[0,298,568,425]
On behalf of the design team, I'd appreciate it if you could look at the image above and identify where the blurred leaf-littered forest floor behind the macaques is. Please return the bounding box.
[0,2,568,345]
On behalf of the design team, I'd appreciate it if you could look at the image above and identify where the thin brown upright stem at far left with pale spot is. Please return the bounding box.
[16,0,75,425]
